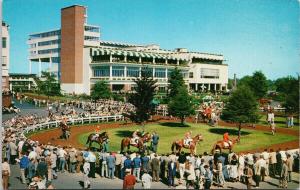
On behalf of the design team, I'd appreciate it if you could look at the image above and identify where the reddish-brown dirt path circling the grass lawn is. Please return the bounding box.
[30,117,299,152]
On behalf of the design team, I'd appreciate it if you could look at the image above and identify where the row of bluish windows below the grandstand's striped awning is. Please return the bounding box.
[93,66,178,78]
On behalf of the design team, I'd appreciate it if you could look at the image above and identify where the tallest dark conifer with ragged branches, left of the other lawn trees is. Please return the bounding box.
[128,68,156,127]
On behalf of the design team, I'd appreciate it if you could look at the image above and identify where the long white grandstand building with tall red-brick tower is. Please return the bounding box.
[28,5,228,94]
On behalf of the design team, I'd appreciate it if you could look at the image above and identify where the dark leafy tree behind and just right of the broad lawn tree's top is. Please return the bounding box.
[250,71,268,99]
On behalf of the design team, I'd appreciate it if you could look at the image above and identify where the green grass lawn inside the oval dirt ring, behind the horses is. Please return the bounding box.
[78,123,297,153]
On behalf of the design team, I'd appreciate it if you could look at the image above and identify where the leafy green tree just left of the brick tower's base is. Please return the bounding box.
[37,71,61,98]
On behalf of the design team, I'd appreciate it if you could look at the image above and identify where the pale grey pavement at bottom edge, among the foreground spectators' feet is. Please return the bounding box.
[9,165,299,189]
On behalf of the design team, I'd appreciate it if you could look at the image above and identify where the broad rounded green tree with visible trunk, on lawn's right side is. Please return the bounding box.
[221,85,259,138]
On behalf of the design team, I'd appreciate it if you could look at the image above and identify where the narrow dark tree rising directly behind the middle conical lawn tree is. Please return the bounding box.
[168,67,185,98]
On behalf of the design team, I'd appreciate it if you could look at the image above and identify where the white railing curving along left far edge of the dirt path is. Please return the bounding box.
[22,115,124,134]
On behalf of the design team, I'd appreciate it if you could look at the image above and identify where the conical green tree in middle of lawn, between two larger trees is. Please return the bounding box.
[168,86,195,124]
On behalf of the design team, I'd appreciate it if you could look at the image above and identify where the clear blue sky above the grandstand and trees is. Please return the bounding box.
[3,0,300,80]
